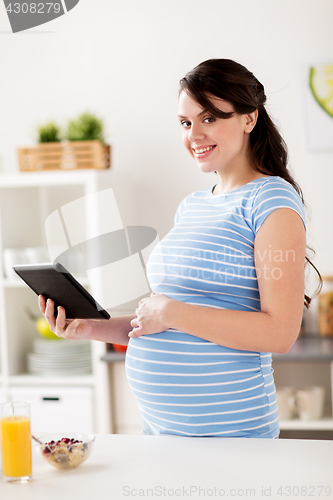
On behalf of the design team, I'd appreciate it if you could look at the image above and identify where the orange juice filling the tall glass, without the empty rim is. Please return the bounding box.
[0,416,32,477]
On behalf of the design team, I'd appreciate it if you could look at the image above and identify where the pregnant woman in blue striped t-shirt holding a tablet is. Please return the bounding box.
[39,59,320,438]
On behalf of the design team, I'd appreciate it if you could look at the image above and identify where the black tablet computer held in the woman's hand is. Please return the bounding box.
[13,263,111,319]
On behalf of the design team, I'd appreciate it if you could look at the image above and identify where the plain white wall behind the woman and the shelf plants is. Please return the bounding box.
[0,0,333,332]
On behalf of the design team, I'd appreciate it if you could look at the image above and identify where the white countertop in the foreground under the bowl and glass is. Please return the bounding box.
[0,434,333,500]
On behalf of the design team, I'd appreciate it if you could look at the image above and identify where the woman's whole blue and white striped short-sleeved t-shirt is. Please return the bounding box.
[126,177,305,438]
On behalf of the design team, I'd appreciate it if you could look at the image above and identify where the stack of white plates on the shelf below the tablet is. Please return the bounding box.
[27,339,92,376]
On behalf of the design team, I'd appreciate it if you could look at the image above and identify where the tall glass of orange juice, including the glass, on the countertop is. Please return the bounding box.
[0,401,32,483]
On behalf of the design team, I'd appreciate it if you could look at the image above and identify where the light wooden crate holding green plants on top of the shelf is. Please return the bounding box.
[18,141,111,172]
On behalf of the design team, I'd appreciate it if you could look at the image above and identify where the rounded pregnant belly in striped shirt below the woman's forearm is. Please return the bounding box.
[126,330,270,435]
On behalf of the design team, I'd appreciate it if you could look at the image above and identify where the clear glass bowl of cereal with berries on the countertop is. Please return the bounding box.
[37,432,95,469]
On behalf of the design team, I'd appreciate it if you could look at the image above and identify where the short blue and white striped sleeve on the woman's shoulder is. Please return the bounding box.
[251,177,306,234]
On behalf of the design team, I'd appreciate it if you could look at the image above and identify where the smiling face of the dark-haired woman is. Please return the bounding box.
[178,91,257,177]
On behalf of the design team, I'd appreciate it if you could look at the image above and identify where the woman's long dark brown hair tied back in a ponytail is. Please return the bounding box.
[179,59,322,308]
